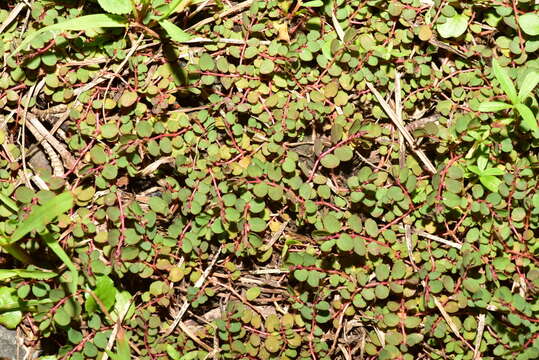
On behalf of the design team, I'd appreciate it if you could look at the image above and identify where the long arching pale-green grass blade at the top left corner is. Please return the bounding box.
[11,14,127,56]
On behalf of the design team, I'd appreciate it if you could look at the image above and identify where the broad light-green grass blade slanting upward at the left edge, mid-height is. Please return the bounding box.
[9,192,73,243]
